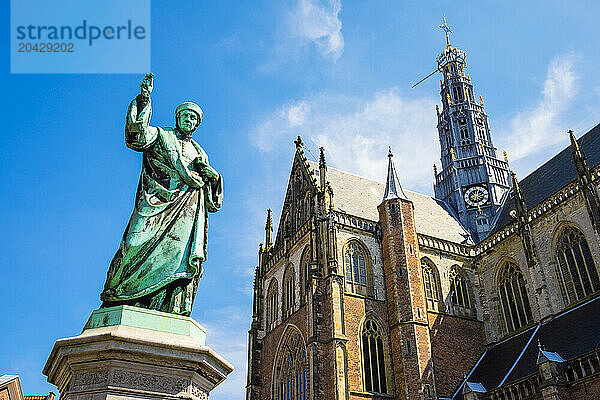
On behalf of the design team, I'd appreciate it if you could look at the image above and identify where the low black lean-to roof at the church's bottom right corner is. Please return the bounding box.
[453,297,600,400]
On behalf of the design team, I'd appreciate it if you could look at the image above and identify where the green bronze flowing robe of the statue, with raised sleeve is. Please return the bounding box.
[100,99,223,314]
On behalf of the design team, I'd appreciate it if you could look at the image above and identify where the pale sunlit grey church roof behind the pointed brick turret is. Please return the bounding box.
[308,161,471,243]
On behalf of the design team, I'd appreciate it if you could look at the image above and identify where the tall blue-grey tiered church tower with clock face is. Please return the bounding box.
[434,18,509,241]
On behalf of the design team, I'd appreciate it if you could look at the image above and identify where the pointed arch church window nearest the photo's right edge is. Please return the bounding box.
[556,226,600,305]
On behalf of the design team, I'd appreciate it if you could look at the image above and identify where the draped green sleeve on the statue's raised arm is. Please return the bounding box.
[125,97,158,151]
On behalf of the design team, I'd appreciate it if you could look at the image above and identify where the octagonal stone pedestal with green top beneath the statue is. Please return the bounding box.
[43,306,233,400]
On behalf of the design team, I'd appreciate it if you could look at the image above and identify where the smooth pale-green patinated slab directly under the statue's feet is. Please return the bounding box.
[83,305,206,345]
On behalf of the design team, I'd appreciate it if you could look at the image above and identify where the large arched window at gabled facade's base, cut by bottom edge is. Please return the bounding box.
[274,329,308,400]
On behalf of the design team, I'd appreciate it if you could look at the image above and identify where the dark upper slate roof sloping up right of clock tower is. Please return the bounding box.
[491,124,600,233]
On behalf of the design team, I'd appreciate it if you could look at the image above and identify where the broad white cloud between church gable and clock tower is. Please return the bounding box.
[254,88,439,192]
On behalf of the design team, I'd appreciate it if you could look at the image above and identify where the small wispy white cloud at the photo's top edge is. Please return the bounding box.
[288,0,344,61]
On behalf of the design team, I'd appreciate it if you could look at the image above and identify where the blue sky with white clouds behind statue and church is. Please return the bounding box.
[0,0,600,400]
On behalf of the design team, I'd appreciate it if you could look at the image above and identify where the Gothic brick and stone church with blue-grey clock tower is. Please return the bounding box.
[246,26,600,400]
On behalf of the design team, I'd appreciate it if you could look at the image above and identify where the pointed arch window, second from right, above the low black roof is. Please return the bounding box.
[498,261,533,333]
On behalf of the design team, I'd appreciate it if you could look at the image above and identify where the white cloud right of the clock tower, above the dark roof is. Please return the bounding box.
[499,55,578,160]
